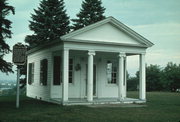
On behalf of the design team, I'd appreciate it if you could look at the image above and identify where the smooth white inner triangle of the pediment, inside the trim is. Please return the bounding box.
[71,23,140,44]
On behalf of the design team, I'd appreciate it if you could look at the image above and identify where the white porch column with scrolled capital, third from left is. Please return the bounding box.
[118,53,126,101]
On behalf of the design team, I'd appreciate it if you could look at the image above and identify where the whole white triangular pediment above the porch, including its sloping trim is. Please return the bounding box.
[61,17,153,47]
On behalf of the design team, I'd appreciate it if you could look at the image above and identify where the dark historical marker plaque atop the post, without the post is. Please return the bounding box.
[13,43,27,65]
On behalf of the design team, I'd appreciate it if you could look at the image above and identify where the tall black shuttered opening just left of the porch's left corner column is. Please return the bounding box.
[53,56,62,85]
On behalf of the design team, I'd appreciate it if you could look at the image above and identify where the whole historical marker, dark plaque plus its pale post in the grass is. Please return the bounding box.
[12,43,27,108]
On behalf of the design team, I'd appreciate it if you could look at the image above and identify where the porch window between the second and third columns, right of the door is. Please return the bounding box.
[106,61,117,84]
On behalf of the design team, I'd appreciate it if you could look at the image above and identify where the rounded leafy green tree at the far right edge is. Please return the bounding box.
[161,62,180,91]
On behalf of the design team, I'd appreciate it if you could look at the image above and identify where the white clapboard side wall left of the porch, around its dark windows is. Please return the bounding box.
[27,49,52,99]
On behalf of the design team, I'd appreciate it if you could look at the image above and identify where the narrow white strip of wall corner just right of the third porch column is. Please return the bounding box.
[124,57,127,98]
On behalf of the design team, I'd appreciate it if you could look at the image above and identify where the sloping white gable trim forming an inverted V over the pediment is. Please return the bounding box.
[61,16,154,47]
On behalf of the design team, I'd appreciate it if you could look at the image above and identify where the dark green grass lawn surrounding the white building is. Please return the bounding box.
[0,92,180,122]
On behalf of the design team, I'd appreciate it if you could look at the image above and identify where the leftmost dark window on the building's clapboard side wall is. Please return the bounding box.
[28,63,34,84]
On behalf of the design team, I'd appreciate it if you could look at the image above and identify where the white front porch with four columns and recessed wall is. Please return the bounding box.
[56,48,146,105]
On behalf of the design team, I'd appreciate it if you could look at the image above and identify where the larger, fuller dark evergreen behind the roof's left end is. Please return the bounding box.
[25,0,70,47]
